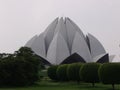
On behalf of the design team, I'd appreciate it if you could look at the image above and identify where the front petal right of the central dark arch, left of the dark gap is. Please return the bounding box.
[72,32,92,62]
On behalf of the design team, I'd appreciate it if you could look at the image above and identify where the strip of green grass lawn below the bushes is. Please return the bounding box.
[0,81,120,90]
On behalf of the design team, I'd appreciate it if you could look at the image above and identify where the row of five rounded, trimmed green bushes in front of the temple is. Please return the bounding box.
[48,63,120,89]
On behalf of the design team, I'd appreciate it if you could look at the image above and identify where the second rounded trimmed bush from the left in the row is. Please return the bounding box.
[56,64,68,81]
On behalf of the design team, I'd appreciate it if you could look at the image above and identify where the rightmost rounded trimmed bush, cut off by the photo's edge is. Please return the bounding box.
[99,63,120,89]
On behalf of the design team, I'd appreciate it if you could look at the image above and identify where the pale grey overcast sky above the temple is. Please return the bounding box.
[0,0,120,60]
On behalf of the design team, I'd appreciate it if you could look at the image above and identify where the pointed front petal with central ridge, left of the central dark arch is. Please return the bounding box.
[47,33,70,65]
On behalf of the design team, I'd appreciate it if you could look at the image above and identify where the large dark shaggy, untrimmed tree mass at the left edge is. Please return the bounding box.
[0,48,40,86]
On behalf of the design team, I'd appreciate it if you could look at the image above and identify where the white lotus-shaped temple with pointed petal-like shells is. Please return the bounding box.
[25,18,110,65]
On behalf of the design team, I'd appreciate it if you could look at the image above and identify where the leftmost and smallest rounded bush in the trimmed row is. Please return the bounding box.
[47,65,58,81]
